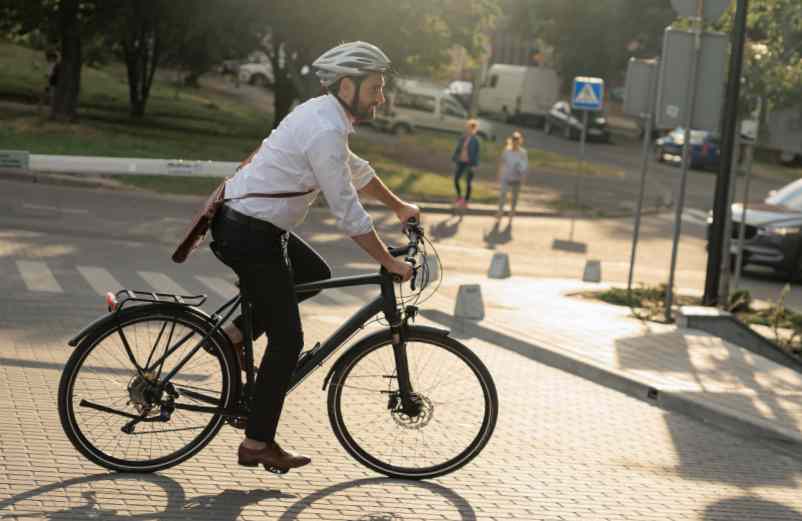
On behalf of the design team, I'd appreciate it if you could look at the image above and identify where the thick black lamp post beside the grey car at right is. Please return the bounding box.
[703,0,749,306]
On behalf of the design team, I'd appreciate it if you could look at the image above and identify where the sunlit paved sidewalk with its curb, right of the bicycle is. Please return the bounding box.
[427,276,802,456]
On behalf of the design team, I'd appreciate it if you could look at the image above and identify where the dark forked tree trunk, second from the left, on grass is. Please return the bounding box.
[123,0,161,118]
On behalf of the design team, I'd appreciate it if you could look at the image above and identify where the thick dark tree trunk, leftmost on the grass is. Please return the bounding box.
[50,0,82,121]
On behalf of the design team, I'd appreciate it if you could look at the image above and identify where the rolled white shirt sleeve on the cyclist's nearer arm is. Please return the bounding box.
[306,129,374,237]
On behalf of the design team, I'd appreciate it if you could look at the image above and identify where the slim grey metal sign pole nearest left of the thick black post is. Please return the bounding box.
[665,5,704,322]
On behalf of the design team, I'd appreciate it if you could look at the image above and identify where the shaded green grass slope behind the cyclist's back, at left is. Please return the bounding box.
[0,42,272,161]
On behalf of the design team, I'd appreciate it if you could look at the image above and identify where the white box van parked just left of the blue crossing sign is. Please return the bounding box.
[478,63,560,127]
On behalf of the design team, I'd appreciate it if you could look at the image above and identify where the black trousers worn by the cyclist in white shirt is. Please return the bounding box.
[212,208,331,442]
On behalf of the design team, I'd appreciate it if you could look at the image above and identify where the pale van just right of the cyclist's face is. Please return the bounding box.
[373,79,495,141]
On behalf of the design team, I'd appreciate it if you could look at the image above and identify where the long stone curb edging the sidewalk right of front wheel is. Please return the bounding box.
[420,309,802,459]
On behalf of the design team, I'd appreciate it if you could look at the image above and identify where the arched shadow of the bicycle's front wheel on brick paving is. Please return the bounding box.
[278,478,476,521]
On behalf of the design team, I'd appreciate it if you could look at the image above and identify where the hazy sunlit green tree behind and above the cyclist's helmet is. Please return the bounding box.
[251,0,497,127]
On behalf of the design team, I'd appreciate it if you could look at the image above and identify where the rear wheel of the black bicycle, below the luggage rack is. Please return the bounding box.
[58,304,238,472]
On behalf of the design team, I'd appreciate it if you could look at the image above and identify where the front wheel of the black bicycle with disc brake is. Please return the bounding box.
[328,327,498,479]
